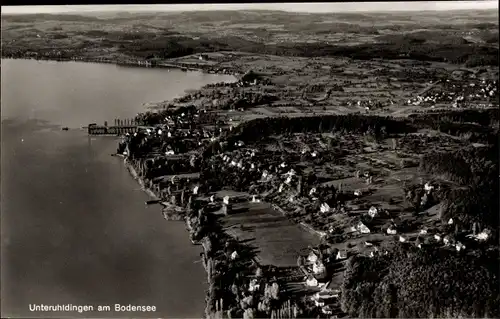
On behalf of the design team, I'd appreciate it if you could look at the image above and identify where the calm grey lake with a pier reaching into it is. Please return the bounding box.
[1,59,235,318]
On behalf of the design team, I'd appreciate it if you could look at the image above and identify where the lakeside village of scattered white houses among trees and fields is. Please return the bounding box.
[117,59,498,318]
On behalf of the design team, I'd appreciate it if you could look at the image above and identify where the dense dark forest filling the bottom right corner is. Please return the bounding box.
[341,244,500,318]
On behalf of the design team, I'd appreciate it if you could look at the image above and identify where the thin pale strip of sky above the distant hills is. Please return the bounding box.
[1,1,498,14]
